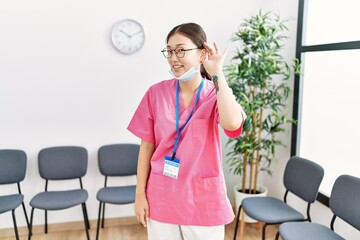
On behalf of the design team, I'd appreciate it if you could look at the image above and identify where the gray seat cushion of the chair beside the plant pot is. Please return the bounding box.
[241,197,304,224]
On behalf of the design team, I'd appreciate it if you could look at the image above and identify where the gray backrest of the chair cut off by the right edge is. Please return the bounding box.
[329,175,360,230]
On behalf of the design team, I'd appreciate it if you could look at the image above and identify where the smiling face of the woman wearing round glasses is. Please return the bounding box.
[167,33,205,77]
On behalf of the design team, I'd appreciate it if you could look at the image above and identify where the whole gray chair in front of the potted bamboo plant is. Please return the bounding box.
[234,156,324,240]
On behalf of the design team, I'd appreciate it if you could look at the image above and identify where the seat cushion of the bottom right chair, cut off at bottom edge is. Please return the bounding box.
[279,222,344,240]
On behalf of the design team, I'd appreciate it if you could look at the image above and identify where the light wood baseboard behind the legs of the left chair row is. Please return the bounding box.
[0,217,139,238]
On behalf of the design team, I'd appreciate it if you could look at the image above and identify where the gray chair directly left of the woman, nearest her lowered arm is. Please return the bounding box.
[96,143,140,239]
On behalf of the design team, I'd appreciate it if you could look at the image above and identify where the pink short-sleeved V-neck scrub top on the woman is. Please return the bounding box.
[128,79,245,226]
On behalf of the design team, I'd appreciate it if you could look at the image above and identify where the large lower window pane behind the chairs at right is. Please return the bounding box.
[298,49,360,196]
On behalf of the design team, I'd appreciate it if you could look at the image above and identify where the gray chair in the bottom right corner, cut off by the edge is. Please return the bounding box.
[276,175,360,240]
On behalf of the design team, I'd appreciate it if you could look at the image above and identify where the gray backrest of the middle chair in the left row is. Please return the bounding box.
[38,146,88,180]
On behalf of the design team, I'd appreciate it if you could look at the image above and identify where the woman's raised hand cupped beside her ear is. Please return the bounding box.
[202,42,228,75]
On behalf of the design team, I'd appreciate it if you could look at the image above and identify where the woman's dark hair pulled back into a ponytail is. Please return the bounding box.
[166,23,211,79]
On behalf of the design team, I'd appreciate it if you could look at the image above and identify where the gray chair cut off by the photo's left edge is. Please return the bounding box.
[0,149,29,240]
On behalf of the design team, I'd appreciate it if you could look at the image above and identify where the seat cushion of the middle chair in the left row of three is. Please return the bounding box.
[30,189,88,210]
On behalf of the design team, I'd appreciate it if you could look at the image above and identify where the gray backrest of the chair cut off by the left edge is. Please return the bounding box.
[0,149,27,184]
